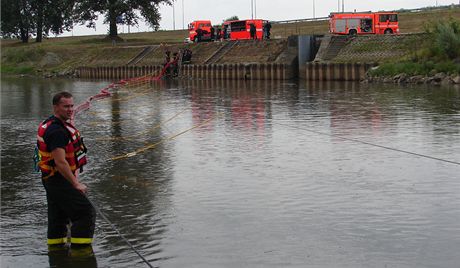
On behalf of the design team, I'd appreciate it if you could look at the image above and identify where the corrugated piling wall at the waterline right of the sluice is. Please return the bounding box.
[305,62,375,81]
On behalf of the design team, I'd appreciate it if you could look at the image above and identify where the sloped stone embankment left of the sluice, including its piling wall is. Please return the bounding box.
[76,39,298,80]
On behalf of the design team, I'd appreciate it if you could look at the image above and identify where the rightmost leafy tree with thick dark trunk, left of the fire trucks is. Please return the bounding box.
[75,0,171,39]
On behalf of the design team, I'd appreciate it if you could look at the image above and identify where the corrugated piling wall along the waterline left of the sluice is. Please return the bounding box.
[77,63,297,80]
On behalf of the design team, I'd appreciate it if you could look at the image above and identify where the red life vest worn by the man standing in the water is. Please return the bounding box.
[37,116,87,179]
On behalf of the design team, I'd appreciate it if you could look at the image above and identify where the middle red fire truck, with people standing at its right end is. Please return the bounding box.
[222,20,267,40]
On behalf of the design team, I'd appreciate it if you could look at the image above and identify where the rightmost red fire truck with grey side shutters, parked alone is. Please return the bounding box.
[329,12,399,35]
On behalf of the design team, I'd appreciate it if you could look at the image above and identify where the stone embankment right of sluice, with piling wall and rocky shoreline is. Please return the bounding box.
[306,33,460,85]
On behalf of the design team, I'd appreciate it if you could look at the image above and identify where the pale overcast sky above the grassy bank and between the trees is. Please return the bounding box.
[61,0,460,36]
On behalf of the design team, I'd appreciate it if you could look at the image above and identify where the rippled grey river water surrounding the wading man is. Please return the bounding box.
[1,78,460,267]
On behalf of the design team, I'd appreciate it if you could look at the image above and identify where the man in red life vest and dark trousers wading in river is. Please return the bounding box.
[37,92,96,247]
